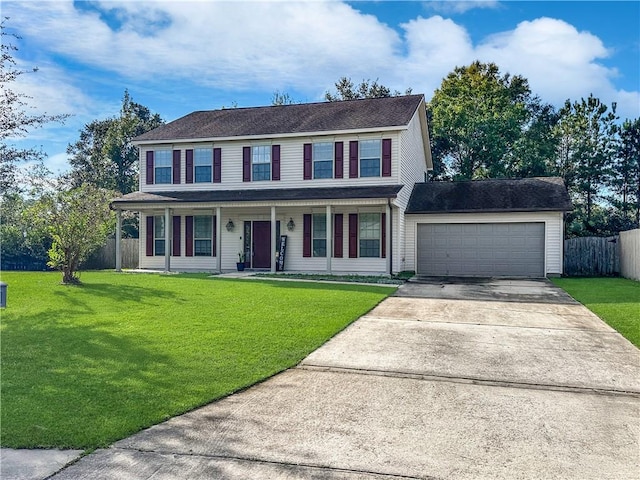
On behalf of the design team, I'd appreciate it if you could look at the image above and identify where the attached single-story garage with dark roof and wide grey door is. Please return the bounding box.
[404,177,573,278]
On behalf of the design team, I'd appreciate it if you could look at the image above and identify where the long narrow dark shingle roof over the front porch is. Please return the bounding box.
[112,185,402,208]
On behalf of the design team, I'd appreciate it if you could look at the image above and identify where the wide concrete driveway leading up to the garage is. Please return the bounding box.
[52,279,640,480]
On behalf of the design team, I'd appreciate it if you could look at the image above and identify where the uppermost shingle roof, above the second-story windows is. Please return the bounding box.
[134,95,423,142]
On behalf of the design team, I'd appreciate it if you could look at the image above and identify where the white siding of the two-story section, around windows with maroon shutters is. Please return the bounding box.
[132,99,430,273]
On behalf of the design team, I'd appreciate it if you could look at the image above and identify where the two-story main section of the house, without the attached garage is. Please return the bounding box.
[113,95,432,273]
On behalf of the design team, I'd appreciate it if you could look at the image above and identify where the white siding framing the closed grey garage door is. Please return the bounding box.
[406,212,564,275]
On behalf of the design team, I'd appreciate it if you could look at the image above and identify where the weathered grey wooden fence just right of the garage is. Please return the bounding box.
[564,237,620,276]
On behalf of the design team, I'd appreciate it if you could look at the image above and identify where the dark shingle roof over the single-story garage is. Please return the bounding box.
[406,177,573,213]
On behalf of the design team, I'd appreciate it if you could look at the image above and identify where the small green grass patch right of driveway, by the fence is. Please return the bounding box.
[551,277,640,348]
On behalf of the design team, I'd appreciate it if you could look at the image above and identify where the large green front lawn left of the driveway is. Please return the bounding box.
[0,272,394,449]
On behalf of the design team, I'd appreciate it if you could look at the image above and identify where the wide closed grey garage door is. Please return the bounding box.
[417,222,544,277]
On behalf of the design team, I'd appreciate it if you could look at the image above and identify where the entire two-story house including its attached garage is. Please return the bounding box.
[112,95,571,276]
